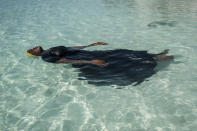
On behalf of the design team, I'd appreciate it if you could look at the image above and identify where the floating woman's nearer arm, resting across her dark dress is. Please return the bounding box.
[56,58,107,66]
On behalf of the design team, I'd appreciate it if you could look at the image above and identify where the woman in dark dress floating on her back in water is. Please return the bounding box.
[27,42,174,85]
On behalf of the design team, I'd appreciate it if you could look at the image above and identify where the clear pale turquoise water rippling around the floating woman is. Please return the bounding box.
[0,0,197,131]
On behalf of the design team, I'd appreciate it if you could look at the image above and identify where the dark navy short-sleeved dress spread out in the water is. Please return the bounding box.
[42,46,157,86]
